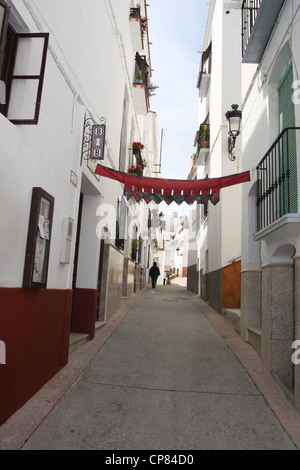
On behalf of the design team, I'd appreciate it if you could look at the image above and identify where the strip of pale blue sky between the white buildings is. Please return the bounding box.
[147,0,209,179]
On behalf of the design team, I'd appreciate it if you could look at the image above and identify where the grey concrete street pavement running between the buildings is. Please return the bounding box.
[0,279,300,450]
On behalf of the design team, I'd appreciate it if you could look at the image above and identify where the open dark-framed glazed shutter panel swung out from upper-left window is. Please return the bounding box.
[7,33,49,124]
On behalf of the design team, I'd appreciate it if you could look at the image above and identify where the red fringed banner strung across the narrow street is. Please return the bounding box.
[95,165,251,204]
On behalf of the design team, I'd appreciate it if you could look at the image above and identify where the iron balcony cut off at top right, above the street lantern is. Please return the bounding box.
[242,0,285,64]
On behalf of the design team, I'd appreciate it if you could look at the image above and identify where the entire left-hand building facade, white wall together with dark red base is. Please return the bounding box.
[0,0,157,423]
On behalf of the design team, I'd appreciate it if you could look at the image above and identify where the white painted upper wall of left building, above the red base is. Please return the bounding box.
[0,0,156,289]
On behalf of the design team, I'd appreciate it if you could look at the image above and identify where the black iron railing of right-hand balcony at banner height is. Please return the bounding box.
[256,127,300,231]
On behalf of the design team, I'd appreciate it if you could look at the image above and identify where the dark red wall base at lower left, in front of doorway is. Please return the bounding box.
[0,288,73,425]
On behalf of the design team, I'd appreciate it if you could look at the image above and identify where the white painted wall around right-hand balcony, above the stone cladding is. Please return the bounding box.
[242,1,300,269]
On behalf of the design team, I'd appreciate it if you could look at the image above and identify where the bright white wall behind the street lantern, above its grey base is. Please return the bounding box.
[198,1,242,272]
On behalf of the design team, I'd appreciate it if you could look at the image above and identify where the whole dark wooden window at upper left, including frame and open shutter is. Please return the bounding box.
[0,0,49,124]
